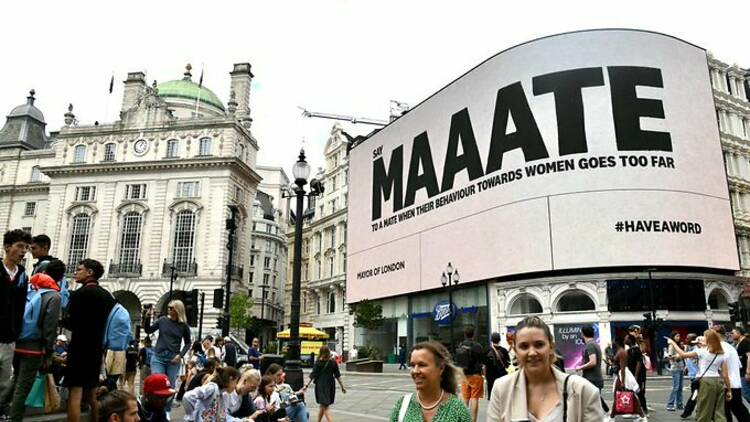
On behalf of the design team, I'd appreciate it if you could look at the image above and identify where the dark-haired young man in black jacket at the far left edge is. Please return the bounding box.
[0,229,31,414]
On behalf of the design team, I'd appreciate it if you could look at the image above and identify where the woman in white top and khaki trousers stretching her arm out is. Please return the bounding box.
[667,330,732,422]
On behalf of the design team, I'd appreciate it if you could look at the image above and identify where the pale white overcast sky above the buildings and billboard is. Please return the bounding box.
[0,0,750,176]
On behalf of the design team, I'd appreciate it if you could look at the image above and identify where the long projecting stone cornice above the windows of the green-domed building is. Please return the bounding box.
[40,157,261,184]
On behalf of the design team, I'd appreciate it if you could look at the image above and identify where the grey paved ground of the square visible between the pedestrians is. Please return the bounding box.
[25,365,748,422]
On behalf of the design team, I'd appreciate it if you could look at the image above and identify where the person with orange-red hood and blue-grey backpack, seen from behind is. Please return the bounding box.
[9,260,65,421]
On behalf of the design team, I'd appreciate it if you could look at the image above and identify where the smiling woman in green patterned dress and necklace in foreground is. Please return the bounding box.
[390,341,471,422]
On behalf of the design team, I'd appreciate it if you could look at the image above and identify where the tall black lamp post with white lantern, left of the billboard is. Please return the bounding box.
[284,149,323,391]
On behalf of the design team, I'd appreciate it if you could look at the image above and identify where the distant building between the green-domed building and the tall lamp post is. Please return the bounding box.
[248,166,289,344]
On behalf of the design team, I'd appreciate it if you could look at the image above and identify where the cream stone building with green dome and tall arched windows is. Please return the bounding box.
[0,63,260,333]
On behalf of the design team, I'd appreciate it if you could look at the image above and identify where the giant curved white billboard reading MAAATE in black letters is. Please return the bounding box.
[347,30,739,302]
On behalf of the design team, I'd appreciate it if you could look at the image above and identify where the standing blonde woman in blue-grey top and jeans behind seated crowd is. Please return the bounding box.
[146,300,192,411]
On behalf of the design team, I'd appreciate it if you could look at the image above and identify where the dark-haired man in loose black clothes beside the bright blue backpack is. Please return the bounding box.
[63,258,117,422]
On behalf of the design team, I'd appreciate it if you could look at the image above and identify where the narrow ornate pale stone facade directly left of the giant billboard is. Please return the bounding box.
[284,124,352,353]
